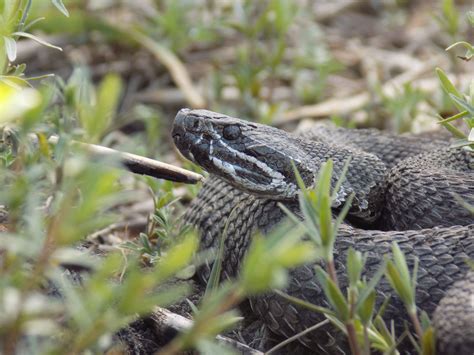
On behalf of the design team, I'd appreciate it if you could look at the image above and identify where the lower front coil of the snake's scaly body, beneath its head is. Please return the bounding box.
[185,176,474,354]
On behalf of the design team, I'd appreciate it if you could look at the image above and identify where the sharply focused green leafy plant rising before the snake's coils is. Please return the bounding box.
[277,160,434,354]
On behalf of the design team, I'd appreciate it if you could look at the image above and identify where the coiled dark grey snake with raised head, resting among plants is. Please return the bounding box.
[172,109,474,355]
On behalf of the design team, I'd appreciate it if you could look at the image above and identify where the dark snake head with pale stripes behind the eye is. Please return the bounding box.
[172,109,314,199]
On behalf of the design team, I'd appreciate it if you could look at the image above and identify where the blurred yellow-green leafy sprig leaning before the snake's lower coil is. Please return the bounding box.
[156,224,317,354]
